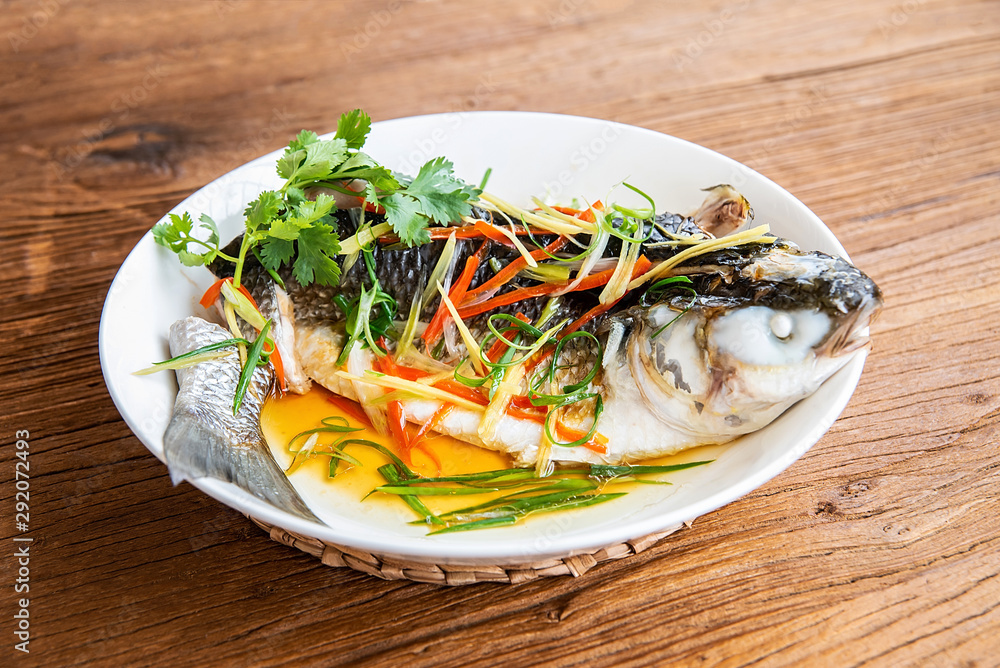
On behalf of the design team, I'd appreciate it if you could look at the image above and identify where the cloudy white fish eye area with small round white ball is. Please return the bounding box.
[708,306,831,366]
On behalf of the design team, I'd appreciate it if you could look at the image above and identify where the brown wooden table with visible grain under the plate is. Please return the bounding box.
[0,0,1000,666]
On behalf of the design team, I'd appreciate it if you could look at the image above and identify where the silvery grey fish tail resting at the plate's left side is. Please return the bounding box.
[163,317,319,522]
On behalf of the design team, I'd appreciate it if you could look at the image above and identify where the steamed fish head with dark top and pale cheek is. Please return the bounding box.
[623,242,882,443]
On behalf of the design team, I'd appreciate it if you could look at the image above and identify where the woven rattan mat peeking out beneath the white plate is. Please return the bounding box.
[250,517,681,585]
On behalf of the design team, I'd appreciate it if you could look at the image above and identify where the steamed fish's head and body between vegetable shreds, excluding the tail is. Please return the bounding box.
[189,197,881,466]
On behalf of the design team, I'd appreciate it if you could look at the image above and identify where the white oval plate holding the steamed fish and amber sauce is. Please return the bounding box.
[100,112,864,564]
